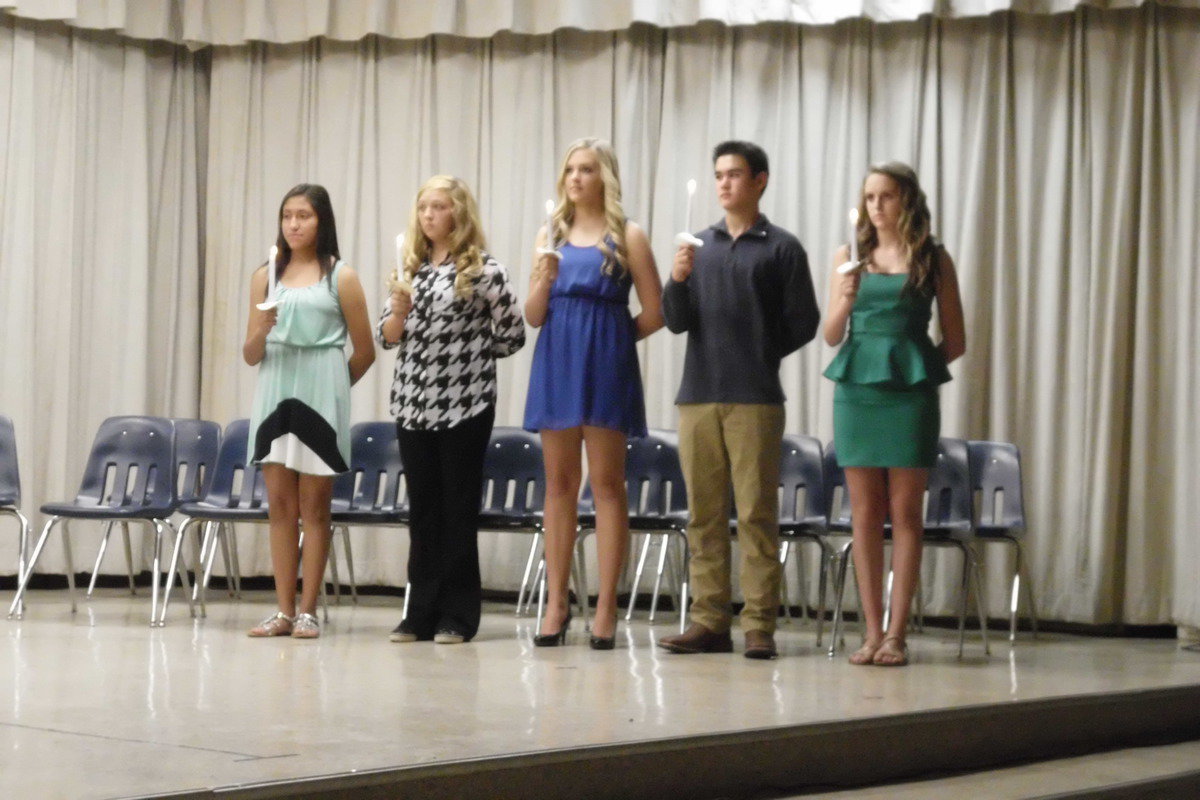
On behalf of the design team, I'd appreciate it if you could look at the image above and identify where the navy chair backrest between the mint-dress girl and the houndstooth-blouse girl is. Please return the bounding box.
[334,420,408,513]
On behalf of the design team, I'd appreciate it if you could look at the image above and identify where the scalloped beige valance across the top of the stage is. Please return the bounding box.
[0,0,1200,47]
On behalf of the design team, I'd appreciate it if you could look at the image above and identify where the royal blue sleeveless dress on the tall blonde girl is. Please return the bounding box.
[524,243,646,437]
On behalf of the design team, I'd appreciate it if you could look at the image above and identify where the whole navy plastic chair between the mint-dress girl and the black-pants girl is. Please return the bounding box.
[330,421,408,602]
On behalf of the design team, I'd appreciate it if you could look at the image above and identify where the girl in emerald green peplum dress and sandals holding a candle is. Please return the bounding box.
[824,163,966,667]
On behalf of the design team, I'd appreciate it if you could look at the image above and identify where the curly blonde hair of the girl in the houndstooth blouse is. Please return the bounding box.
[403,175,487,299]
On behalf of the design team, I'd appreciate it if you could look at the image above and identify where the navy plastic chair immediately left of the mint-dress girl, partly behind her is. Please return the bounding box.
[162,420,268,618]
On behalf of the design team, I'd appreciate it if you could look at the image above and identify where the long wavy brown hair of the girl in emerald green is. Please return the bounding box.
[858,161,940,295]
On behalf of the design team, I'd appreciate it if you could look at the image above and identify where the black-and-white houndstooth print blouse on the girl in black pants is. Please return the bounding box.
[376,253,524,431]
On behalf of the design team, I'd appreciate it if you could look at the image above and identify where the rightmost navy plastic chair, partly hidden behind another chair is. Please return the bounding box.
[967,441,1038,643]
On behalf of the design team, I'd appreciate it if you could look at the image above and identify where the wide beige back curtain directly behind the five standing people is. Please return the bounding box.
[202,6,1200,624]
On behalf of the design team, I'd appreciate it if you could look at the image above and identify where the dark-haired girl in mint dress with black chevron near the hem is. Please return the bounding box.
[242,184,374,638]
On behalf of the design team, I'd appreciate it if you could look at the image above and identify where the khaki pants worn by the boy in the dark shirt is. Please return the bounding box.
[679,403,784,633]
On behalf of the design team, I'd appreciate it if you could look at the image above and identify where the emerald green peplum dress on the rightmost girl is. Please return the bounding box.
[824,272,950,468]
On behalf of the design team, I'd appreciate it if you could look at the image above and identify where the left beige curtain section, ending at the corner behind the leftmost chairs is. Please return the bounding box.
[0,17,206,575]
